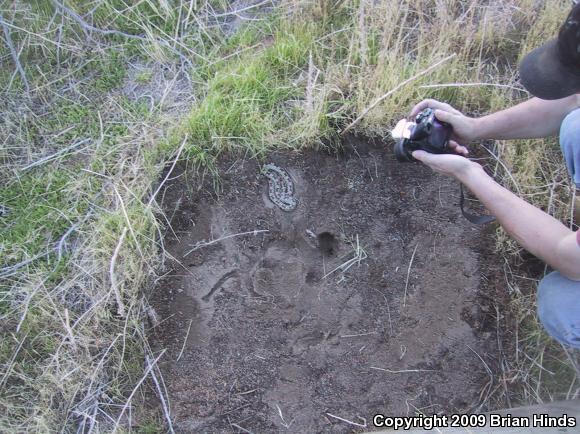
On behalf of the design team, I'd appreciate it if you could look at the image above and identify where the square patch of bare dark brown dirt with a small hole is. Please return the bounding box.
[150,139,497,433]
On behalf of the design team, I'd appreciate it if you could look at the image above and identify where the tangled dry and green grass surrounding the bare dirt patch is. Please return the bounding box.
[0,0,577,432]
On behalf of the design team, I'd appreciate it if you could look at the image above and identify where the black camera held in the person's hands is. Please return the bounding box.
[394,108,453,162]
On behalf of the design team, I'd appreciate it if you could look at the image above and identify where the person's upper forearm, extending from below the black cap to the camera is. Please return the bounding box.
[474,95,580,140]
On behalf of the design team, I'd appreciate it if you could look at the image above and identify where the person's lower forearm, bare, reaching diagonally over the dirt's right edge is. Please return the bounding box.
[457,164,580,280]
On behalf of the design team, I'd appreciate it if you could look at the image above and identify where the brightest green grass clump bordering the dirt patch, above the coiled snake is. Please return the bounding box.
[187,26,315,154]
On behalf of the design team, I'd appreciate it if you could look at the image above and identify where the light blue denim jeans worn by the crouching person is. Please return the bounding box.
[538,109,580,351]
